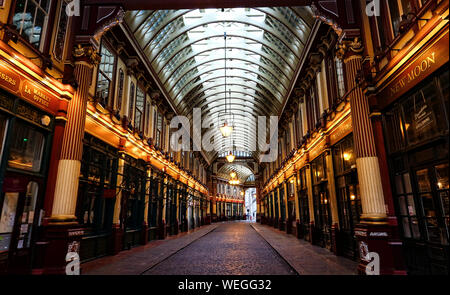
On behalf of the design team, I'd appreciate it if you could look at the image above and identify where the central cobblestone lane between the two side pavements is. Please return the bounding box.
[145,222,295,275]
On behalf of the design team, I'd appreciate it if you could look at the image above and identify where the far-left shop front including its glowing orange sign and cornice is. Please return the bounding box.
[0,42,72,274]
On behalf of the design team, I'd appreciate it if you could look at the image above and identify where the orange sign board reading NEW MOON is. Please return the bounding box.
[378,32,449,107]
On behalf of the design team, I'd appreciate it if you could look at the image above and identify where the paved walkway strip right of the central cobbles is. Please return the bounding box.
[252,223,358,275]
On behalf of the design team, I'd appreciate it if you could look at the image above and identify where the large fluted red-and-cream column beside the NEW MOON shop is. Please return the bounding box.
[339,39,395,274]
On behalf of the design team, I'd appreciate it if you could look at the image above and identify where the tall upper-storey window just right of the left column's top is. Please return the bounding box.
[95,43,116,107]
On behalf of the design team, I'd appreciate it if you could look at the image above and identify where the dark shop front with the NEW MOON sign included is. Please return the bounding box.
[377,24,450,275]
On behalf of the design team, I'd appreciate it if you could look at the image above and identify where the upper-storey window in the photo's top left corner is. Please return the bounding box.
[12,0,51,51]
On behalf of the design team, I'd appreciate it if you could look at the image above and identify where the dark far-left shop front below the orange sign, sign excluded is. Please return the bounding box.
[0,90,54,273]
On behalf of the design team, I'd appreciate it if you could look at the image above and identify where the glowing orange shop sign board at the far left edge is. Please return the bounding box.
[0,61,60,115]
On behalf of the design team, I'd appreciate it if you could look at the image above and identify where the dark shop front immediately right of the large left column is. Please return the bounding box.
[76,133,119,261]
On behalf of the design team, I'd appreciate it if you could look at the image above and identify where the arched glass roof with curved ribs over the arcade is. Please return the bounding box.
[125,7,314,164]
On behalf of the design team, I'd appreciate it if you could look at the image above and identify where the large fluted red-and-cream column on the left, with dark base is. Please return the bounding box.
[41,46,99,274]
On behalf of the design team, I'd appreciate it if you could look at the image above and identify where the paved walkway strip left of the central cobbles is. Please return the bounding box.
[81,223,220,275]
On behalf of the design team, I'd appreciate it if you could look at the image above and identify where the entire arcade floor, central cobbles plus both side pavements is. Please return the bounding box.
[82,222,357,275]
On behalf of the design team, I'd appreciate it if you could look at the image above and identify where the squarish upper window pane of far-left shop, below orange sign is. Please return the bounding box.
[8,121,45,172]
